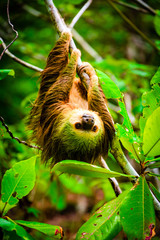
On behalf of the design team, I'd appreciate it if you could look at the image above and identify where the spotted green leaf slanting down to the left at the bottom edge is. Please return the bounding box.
[76,191,128,240]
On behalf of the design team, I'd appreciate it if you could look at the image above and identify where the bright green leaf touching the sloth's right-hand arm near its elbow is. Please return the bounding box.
[96,70,122,98]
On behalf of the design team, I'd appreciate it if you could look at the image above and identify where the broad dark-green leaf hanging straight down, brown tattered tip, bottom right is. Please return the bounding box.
[120,176,155,240]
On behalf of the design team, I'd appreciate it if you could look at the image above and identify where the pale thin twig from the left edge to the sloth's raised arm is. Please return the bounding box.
[0,38,43,72]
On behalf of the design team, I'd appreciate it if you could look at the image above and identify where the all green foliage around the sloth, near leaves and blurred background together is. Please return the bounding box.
[0,0,160,240]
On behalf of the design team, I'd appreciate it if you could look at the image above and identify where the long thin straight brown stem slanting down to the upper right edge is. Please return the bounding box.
[107,0,159,51]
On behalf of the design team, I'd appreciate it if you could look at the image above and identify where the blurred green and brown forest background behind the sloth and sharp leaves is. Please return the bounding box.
[0,0,160,239]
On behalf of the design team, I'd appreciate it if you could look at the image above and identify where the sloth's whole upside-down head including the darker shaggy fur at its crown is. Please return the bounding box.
[52,109,107,162]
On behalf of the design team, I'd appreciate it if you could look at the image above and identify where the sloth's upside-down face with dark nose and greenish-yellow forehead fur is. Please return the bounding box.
[58,109,105,152]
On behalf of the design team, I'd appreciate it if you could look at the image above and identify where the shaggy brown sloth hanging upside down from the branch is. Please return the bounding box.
[28,32,115,164]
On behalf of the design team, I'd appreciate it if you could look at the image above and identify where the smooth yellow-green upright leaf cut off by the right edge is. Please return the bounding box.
[143,107,160,157]
